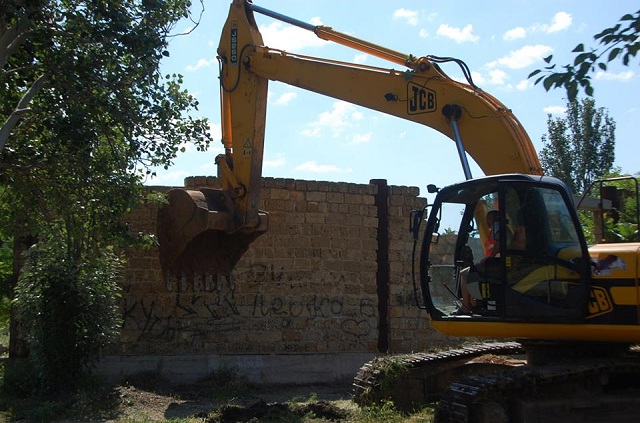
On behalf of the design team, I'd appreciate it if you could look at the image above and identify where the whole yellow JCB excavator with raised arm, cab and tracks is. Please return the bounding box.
[158,0,640,422]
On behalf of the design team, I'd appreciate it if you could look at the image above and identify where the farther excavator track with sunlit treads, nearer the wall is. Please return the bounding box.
[353,342,524,410]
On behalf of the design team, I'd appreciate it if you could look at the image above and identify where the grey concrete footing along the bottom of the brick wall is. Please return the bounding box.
[97,353,375,385]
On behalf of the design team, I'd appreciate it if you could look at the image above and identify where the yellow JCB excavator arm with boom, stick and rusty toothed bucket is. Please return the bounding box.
[158,0,542,282]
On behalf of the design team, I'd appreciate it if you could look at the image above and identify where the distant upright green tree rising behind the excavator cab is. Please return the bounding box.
[540,98,616,194]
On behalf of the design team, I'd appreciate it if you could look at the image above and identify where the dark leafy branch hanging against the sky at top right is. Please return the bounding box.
[529,10,640,101]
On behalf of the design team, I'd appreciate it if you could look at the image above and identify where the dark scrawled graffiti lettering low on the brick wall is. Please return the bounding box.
[123,266,377,347]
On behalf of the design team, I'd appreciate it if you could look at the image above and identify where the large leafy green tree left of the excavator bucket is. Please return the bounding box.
[0,0,210,386]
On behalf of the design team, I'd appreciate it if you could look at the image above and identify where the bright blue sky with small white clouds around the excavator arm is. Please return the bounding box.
[146,0,640,195]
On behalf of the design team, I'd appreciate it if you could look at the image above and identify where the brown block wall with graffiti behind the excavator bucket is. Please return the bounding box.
[111,177,458,355]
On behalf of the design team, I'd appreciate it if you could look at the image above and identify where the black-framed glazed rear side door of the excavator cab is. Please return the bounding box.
[497,183,589,322]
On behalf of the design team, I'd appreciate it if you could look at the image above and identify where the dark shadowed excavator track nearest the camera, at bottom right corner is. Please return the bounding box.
[435,357,640,423]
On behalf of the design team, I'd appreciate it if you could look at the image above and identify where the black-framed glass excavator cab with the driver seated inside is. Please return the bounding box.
[429,178,585,319]
